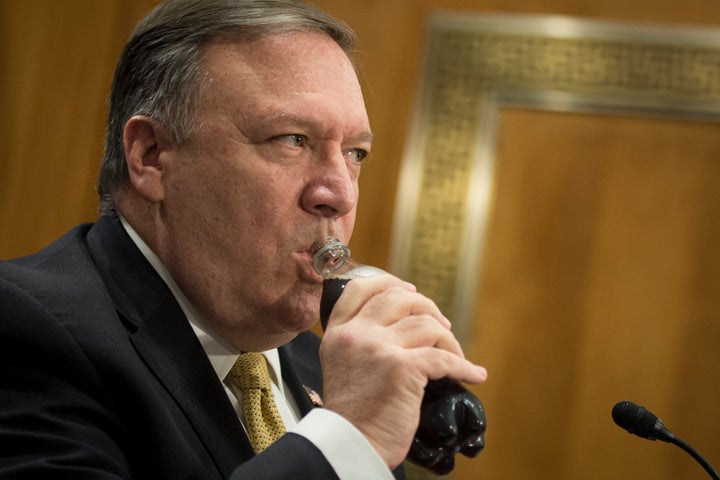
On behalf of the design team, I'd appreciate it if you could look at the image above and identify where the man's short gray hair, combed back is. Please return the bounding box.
[98,0,355,214]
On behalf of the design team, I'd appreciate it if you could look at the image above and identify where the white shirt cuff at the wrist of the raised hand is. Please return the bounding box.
[291,408,394,480]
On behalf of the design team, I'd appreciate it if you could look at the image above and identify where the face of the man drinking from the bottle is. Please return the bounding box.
[159,32,371,350]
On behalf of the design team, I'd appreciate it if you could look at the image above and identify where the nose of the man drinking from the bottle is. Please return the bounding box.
[301,147,359,218]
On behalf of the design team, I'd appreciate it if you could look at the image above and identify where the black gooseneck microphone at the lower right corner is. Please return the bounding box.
[612,401,720,480]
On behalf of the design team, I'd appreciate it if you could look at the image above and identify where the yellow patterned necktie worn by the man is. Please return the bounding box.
[230,352,285,453]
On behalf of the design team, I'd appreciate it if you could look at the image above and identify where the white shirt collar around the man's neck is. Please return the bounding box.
[118,214,283,390]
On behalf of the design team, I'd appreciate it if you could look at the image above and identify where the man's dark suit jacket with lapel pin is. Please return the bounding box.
[0,216,404,480]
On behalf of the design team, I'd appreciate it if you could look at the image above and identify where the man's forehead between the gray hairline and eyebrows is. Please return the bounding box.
[197,32,367,127]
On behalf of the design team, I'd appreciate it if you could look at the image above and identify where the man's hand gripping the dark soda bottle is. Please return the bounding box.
[320,275,487,468]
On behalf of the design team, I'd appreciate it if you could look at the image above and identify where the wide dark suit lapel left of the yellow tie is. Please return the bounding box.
[88,217,253,478]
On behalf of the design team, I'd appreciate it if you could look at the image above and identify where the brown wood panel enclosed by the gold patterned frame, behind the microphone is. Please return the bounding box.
[466,108,720,480]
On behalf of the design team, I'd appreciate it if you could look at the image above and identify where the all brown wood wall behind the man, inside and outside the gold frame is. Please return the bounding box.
[0,0,720,480]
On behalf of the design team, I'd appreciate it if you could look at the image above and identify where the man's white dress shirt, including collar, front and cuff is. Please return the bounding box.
[120,216,394,480]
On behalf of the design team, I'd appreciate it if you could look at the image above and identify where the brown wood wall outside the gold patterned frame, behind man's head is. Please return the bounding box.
[0,0,720,260]
